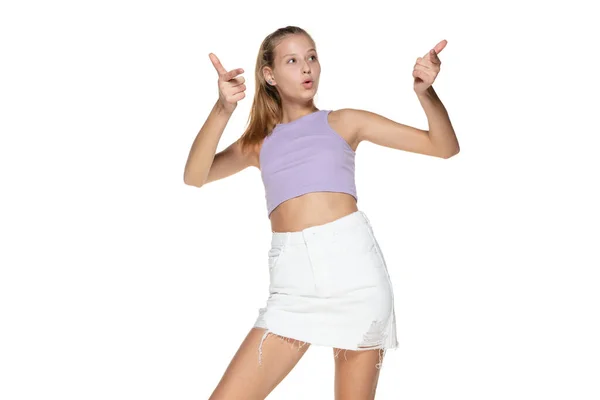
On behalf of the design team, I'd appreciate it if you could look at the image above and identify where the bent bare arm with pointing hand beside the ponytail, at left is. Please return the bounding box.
[183,53,248,187]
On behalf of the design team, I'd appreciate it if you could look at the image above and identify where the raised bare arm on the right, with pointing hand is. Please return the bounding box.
[352,40,460,158]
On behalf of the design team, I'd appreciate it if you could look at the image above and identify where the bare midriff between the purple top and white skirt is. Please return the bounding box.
[270,192,358,233]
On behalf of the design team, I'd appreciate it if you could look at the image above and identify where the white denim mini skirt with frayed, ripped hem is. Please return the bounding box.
[254,210,398,367]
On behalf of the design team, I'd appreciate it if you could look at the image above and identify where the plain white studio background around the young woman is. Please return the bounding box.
[0,1,600,400]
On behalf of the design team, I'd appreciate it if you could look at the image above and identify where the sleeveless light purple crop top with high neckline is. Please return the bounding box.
[259,110,358,218]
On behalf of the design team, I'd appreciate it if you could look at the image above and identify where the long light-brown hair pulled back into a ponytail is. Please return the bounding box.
[240,26,316,155]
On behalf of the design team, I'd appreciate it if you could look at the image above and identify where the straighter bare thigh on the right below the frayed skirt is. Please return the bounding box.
[333,348,385,400]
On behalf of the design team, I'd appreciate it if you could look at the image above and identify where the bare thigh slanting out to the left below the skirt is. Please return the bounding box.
[209,328,310,400]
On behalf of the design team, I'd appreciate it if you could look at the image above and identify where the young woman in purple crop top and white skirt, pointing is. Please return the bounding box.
[184,26,459,400]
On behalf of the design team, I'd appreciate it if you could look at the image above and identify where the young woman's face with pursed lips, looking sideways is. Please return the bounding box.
[265,34,321,99]
